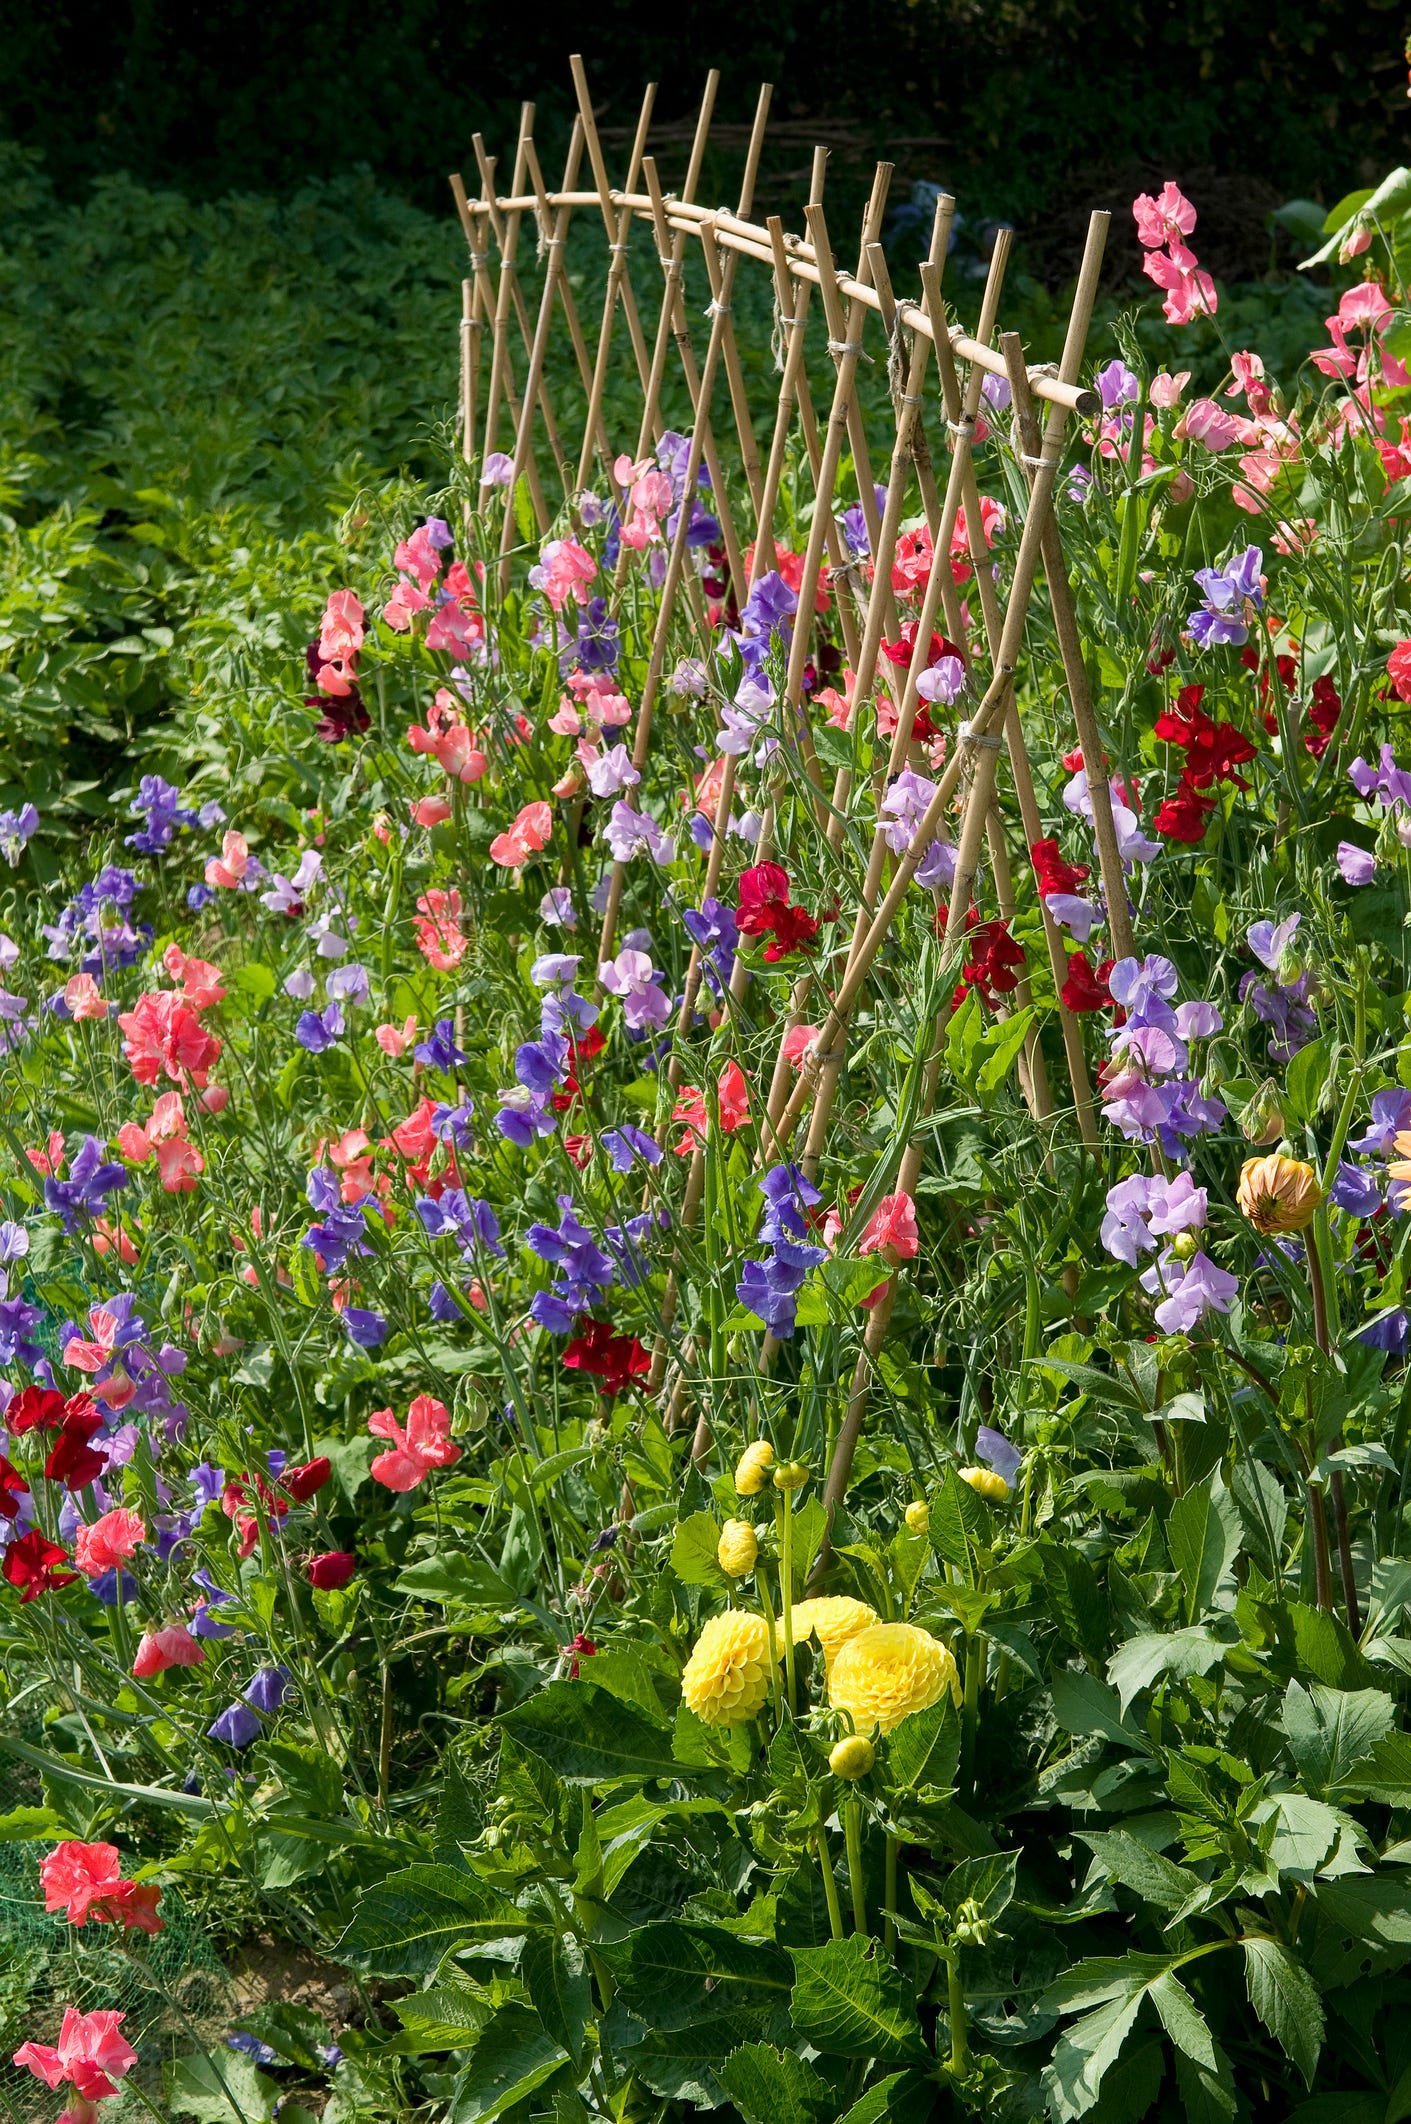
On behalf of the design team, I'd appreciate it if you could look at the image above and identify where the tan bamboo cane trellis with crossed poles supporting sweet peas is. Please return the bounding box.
[451,57,1131,1506]
